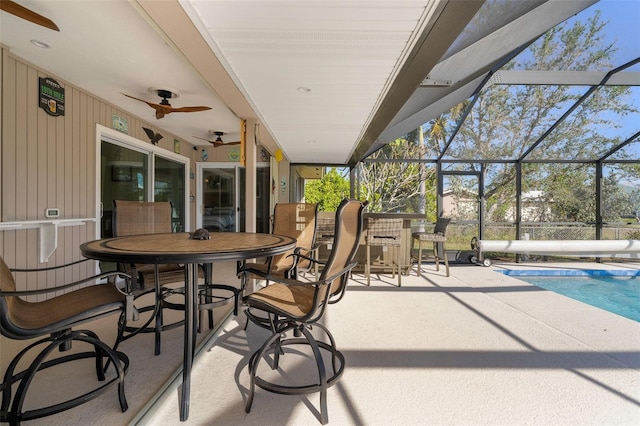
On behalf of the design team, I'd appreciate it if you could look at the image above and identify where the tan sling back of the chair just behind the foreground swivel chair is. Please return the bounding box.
[271,203,318,268]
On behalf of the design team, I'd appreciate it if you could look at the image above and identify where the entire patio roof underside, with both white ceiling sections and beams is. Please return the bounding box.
[0,0,593,164]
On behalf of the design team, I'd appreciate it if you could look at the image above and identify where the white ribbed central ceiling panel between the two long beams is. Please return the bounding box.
[183,0,438,163]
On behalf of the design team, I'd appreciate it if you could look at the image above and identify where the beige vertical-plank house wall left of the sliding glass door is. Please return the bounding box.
[0,50,198,288]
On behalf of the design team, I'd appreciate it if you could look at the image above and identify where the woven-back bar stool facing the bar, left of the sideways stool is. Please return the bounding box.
[365,217,402,287]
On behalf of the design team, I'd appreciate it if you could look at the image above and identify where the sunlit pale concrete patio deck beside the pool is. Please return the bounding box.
[139,262,640,425]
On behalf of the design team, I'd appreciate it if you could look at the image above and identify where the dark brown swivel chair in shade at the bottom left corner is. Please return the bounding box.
[0,257,129,425]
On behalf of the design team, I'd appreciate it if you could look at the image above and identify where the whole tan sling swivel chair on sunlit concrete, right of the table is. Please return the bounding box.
[245,200,366,424]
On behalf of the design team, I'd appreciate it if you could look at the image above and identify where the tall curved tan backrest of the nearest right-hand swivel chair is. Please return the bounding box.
[320,199,367,300]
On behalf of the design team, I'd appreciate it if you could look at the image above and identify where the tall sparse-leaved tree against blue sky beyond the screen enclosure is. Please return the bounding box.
[429,13,638,220]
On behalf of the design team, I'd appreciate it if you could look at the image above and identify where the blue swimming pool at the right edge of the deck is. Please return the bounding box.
[501,269,640,322]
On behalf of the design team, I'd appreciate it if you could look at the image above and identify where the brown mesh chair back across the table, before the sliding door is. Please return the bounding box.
[112,200,172,237]
